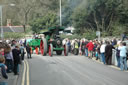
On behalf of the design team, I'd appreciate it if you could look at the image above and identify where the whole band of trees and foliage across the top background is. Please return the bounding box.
[0,0,128,36]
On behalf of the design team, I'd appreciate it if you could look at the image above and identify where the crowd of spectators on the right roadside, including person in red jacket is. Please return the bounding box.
[63,38,128,71]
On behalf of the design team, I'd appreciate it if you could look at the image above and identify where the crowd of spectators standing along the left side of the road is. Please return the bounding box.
[0,40,32,85]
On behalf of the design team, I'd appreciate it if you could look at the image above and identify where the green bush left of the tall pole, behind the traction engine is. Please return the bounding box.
[30,13,57,33]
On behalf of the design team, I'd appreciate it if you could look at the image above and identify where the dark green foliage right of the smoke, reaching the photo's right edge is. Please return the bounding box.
[72,0,128,36]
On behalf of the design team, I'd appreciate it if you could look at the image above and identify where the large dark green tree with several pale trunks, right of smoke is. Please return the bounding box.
[72,0,121,35]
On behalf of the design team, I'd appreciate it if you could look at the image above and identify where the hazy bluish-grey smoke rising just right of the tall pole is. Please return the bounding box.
[62,0,88,26]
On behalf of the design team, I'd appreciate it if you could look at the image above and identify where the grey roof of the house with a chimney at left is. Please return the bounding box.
[0,26,24,33]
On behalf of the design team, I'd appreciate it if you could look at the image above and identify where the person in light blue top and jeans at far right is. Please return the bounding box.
[118,42,127,71]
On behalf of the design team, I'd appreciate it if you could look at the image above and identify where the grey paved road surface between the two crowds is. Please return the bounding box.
[27,54,128,85]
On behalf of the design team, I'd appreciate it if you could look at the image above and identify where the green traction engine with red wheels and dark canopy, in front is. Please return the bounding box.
[40,26,68,56]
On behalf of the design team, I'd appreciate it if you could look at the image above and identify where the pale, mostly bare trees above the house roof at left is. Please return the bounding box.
[0,0,59,26]
